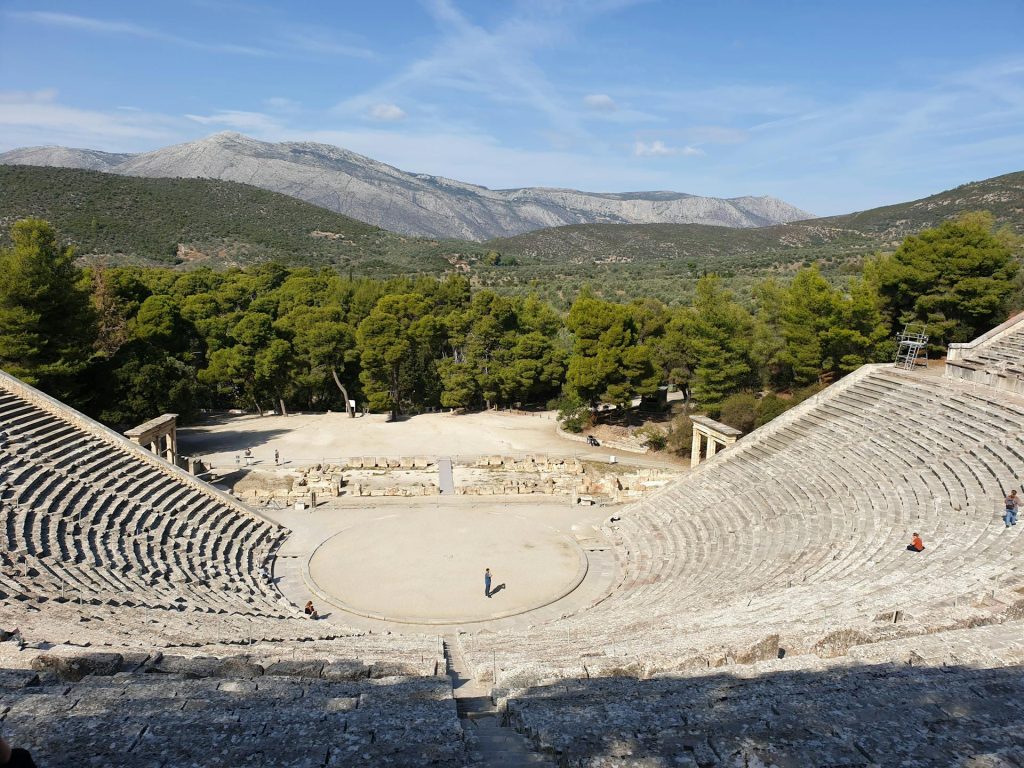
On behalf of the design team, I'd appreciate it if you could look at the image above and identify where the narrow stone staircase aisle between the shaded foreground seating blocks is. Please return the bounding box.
[444,637,554,768]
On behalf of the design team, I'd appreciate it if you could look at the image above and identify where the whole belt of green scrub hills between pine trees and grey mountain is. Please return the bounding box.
[0,166,1024,309]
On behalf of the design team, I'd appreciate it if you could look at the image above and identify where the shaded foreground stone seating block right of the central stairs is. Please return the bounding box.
[508,622,1024,768]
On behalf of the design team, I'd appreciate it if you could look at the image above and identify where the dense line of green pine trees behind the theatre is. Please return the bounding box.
[0,213,1020,442]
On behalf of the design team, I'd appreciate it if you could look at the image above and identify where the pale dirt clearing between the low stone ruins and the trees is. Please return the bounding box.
[178,411,593,468]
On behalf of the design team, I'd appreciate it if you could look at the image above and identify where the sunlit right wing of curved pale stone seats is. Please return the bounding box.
[466,367,1024,685]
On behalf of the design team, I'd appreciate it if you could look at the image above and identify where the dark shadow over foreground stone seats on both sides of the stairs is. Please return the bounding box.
[0,654,1024,768]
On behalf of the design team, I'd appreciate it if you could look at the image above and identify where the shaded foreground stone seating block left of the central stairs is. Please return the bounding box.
[0,651,460,768]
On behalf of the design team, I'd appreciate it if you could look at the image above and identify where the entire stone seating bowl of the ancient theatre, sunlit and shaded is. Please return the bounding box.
[0,318,1024,768]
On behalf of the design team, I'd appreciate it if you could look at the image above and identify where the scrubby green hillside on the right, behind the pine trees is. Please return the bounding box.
[484,172,1024,301]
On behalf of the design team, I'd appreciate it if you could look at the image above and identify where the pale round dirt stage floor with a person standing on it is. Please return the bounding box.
[280,497,607,624]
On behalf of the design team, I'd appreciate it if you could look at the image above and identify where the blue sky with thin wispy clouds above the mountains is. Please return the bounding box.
[0,0,1024,215]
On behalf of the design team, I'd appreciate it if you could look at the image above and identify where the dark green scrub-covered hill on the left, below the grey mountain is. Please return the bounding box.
[0,166,491,275]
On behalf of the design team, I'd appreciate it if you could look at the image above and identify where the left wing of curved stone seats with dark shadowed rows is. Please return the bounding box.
[0,373,294,616]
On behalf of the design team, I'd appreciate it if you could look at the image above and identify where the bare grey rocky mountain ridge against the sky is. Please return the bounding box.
[0,133,811,241]
